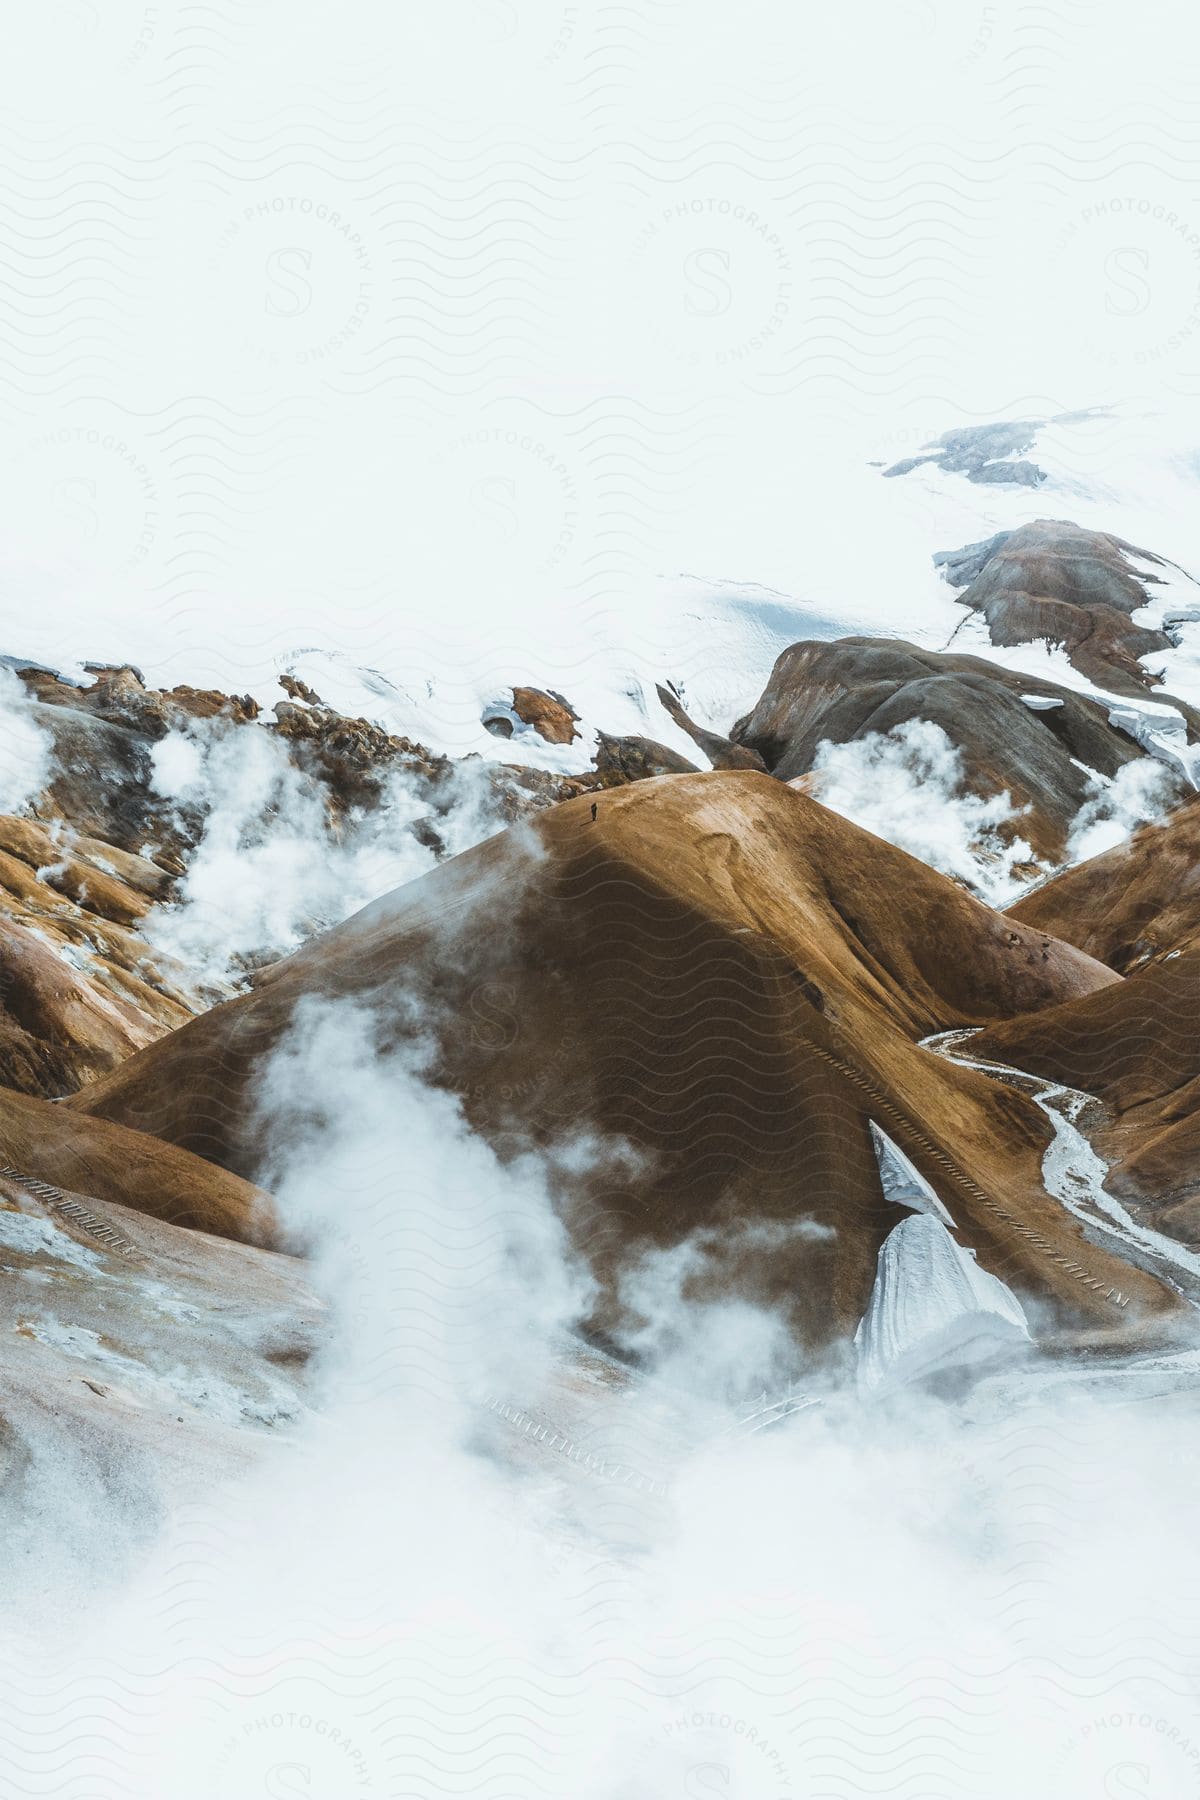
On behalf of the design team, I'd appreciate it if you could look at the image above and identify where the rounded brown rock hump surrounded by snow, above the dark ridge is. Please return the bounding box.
[939,518,1196,698]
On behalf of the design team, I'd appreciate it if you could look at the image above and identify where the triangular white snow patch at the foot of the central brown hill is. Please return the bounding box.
[855,1121,1029,1391]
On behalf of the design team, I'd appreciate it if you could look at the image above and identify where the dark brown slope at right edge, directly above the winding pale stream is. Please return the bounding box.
[973,947,1200,1242]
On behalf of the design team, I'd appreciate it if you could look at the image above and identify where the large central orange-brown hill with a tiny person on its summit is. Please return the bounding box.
[70,772,1173,1339]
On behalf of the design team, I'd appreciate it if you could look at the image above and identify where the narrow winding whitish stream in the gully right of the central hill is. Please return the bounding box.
[921,1026,1200,1303]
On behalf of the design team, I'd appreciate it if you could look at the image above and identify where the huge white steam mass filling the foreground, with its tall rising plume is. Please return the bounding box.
[0,1004,1200,1800]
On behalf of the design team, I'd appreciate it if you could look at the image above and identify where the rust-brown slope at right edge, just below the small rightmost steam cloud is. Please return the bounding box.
[1007,796,1200,972]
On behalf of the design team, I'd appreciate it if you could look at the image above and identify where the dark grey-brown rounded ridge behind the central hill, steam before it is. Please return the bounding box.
[732,637,1144,862]
